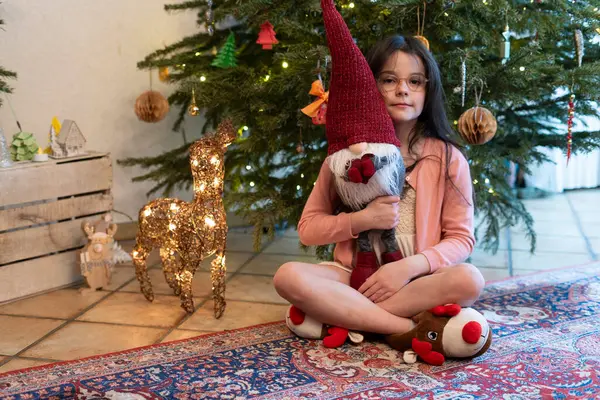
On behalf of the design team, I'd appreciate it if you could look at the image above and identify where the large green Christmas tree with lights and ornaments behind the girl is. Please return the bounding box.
[117,0,600,254]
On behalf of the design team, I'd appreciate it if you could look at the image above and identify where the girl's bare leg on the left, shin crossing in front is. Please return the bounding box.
[273,262,414,334]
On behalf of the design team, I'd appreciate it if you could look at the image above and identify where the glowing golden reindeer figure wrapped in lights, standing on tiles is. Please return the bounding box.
[132,120,235,318]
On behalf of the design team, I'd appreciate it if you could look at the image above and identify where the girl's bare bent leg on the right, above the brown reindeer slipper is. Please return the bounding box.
[377,264,485,317]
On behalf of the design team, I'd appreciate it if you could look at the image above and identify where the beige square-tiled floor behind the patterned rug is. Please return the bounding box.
[0,189,600,372]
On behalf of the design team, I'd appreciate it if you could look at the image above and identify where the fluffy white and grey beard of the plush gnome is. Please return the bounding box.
[327,143,404,211]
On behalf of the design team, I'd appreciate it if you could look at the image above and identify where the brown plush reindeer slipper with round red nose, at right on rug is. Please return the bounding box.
[386,304,492,365]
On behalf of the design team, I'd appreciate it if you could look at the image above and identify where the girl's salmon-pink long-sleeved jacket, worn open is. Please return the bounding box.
[298,138,475,272]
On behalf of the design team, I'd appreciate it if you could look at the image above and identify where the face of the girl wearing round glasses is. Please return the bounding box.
[377,51,427,123]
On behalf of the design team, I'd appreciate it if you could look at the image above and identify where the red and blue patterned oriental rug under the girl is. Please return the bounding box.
[0,263,600,400]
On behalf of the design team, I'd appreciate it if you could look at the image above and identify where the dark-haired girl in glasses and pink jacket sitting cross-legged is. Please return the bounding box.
[274,36,484,334]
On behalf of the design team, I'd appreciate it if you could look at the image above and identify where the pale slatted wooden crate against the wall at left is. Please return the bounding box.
[0,152,113,303]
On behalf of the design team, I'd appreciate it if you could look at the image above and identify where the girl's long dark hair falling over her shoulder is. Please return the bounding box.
[366,35,468,202]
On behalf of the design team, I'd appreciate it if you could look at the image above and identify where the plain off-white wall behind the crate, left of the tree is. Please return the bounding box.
[0,0,201,221]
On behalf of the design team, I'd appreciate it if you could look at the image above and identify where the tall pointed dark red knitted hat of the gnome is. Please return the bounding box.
[321,0,400,154]
